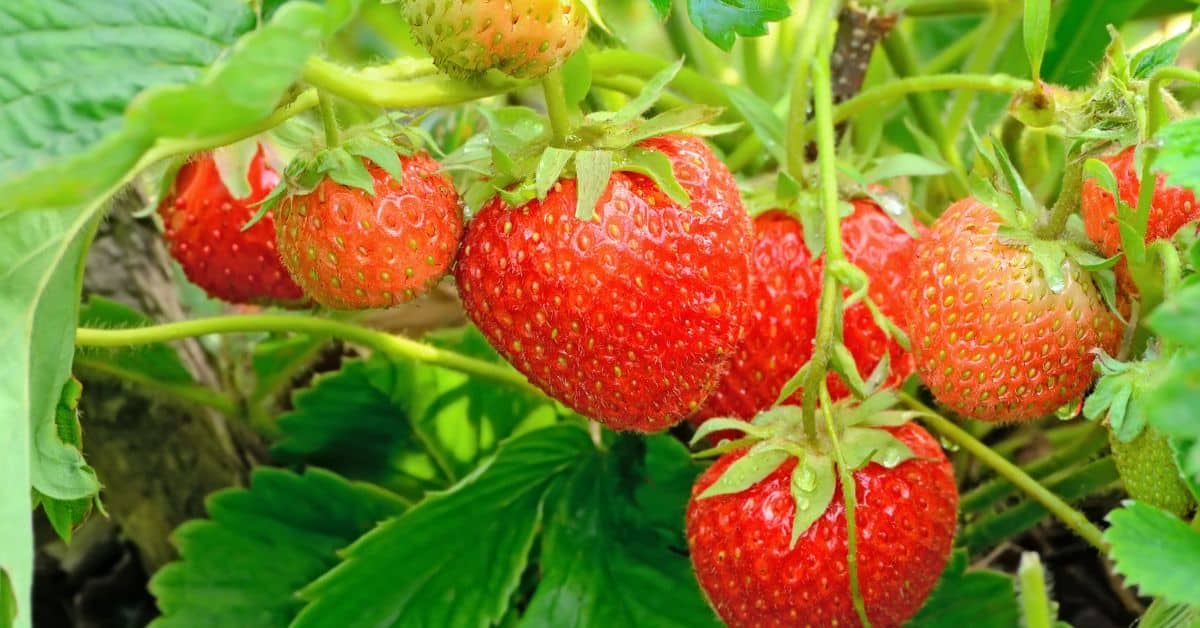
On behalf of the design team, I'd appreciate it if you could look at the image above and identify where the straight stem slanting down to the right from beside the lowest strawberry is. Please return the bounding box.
[899,393,1108,552]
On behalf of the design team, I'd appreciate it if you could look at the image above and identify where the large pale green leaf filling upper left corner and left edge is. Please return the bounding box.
[0,0,357,626]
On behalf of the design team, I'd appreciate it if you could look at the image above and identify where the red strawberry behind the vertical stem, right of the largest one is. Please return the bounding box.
[691,198,916,425]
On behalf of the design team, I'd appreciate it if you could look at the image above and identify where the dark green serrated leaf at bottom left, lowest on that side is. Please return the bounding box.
[150,467,404,628]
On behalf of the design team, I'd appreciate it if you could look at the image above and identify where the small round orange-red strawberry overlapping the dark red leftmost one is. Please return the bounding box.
[277,152,463,310]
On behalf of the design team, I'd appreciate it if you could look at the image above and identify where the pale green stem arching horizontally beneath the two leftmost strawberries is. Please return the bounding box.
[76,315,541,394]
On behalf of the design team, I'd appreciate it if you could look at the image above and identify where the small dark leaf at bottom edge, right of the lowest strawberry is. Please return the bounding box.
[906,550,1020,628]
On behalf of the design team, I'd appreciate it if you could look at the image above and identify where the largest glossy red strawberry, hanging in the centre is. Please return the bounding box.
[455,136,750,431]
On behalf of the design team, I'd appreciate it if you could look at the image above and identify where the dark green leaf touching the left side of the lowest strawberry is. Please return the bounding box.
[521,436,720,628]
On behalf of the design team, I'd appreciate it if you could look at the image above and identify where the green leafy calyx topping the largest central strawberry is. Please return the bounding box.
[443,60,736,220]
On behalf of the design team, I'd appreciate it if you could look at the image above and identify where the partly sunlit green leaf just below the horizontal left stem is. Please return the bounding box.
[271,328,558,500]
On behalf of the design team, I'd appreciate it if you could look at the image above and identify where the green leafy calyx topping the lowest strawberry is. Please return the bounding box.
[691,393,919,548]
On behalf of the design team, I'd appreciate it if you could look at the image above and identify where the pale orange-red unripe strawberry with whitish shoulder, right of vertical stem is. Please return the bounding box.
[905,198,1121,420]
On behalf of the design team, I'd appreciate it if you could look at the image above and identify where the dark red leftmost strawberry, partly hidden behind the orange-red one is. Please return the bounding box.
[158,146,304,305]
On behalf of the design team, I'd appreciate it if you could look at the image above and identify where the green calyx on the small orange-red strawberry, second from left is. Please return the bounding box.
[242,114,433,231]
